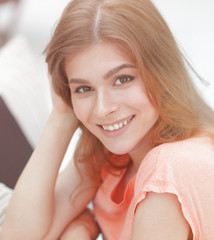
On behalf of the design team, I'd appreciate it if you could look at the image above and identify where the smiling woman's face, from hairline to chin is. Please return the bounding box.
[65,43,158,158]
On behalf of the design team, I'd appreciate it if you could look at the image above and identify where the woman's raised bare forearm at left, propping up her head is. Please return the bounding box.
[2,113,75,240]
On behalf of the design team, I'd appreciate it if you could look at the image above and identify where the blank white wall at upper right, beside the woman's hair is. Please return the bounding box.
[153,0,214,107]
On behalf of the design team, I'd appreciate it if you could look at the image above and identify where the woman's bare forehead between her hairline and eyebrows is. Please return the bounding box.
[65,43,133,75]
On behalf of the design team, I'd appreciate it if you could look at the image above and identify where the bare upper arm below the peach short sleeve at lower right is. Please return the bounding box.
[132,192,191,240]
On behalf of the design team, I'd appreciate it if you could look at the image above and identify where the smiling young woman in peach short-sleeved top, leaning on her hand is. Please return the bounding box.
[2,0,214,240]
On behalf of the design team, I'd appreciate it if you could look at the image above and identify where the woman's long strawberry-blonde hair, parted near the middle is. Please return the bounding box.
[45,0,214,186]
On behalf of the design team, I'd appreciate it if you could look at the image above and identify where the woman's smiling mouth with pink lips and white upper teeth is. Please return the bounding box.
[99,115,135,136]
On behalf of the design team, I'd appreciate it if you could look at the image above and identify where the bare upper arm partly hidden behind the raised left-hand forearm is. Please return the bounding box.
[44,153,97,240]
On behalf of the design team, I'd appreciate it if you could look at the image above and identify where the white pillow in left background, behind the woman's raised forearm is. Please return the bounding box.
[0,36,50,148]
